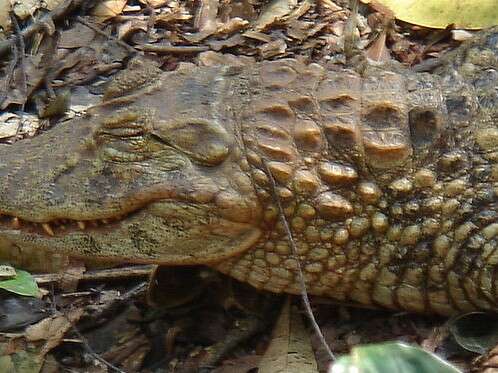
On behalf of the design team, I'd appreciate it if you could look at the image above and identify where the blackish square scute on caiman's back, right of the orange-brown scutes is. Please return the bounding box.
[408,109,441,148]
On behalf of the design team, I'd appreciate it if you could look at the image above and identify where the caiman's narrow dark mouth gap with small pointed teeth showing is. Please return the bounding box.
[0,209,134,237]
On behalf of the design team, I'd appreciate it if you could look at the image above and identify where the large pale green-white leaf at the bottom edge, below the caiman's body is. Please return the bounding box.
[329,342,460,373]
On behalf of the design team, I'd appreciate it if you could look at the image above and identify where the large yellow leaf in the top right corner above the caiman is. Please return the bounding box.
[362,0,498,29]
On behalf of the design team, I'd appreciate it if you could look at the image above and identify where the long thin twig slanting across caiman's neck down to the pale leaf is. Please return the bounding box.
[263,161,335,361]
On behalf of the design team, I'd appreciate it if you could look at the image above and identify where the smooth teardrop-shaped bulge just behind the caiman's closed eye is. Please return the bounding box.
[153,119,231,166]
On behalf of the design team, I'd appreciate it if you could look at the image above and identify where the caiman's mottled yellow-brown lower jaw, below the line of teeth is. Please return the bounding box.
[0,201,261,265]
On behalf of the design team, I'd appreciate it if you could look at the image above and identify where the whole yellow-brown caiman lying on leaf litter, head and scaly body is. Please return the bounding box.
[0,28,498,315]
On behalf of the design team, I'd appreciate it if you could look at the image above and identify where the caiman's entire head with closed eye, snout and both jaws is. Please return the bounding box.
[0,60,260,264]
